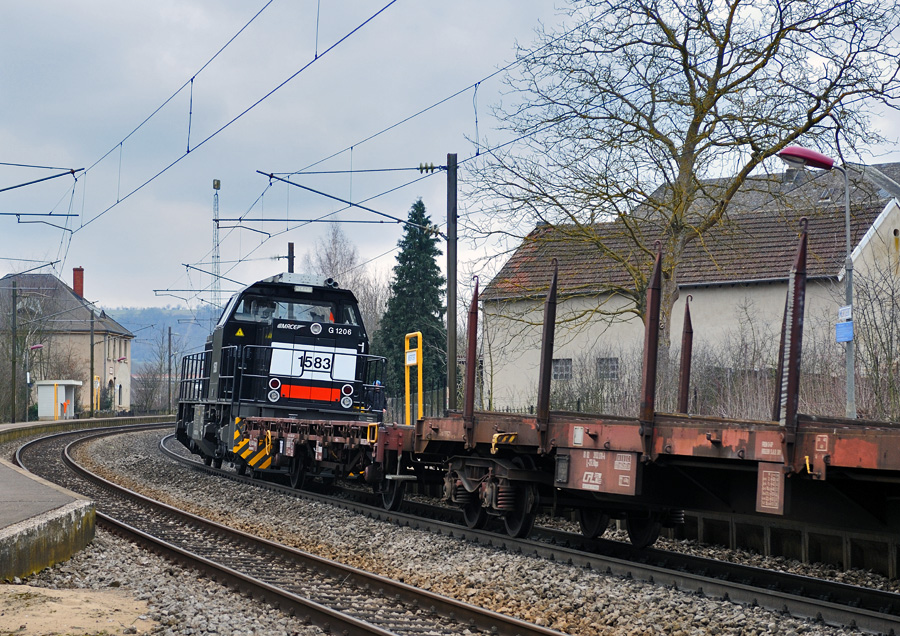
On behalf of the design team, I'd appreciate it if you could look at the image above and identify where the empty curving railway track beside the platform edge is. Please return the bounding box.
[16,426,559,636]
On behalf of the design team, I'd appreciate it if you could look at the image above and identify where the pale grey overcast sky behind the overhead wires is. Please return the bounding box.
[0,0,900,308]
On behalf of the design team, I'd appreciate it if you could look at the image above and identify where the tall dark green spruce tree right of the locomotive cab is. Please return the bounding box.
[372,199,447,395]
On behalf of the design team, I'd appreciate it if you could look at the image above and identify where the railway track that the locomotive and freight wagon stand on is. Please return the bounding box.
[160,430,900,634]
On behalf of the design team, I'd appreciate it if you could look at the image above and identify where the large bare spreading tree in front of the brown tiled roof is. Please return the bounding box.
[466,0,900,337]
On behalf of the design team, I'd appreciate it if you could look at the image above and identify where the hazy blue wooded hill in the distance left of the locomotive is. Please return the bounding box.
[105,307,219,372]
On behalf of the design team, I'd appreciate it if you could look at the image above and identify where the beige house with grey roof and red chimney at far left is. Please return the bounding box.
[0,267,134,421]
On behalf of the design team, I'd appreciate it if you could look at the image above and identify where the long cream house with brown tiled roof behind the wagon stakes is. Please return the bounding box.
[480,164,900,410]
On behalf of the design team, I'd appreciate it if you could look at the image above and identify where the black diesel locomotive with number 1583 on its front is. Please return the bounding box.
[176,273,412,506]
